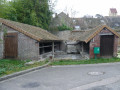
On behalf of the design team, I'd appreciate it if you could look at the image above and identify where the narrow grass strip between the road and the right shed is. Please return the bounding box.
[51,58,120,65]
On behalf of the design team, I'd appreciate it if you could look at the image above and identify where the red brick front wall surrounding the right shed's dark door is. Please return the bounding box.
[89,30,118,58]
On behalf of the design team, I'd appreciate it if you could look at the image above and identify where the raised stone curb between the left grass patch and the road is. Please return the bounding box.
[0,62,51,81]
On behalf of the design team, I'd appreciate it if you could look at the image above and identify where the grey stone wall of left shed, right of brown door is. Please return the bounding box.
[2,25,39,60]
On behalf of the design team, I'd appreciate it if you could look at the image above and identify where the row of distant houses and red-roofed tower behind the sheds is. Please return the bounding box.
[50,8,120,31]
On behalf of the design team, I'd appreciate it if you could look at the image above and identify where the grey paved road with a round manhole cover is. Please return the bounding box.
[0,63,120,90]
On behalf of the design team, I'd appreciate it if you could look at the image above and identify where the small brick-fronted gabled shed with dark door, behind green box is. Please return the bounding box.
[76,25,119,58]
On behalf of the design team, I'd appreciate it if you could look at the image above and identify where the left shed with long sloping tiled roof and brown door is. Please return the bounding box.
[0,19,61,60]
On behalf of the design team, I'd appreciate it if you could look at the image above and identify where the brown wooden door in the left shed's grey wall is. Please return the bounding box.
[4,33,18,58]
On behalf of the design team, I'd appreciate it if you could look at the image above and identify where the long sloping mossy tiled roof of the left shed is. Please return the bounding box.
[0,18,60,41]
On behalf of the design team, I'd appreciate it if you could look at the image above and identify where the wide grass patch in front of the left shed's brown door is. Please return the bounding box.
[0,59,48,77]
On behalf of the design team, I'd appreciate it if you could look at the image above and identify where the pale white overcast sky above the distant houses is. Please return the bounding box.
[53,0,120,17]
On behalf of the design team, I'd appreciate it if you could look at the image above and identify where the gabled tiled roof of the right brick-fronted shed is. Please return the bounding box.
[71,25,120,43]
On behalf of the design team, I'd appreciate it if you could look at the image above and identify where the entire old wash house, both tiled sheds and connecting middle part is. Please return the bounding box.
[0,19,120,60]
